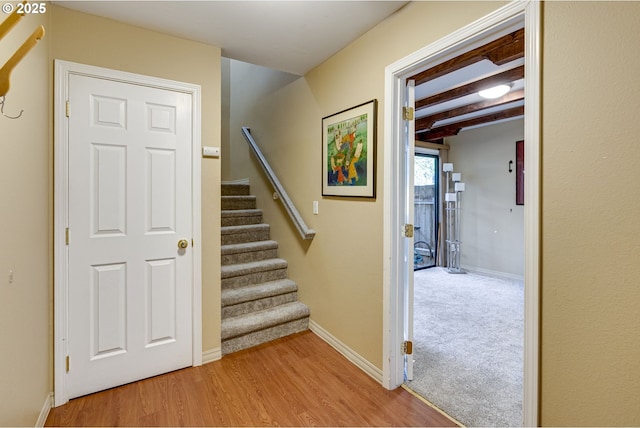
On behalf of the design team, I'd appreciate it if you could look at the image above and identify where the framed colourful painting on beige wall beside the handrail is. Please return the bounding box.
[322,100,378,198]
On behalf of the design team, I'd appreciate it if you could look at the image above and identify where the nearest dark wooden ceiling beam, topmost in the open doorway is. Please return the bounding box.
[407,28,524,86]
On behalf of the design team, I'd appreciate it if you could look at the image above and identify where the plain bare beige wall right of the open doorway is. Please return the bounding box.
[541,2,640,426]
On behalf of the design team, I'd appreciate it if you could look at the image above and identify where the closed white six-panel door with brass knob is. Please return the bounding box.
[66,75,192,398]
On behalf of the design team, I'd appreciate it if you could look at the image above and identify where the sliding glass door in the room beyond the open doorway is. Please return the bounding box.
[413,153,439,270]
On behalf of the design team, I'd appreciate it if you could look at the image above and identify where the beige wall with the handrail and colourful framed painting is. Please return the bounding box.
[230,2,500,369]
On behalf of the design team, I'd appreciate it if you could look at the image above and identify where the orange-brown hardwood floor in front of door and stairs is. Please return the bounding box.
[46,331,455,426]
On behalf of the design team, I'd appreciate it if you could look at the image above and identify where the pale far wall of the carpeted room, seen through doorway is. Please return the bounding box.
[446,119,524,278]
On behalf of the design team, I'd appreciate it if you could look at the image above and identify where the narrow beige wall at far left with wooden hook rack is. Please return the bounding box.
[0,10,51,426]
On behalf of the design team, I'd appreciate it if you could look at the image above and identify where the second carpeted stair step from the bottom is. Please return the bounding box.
[221,279,298,318]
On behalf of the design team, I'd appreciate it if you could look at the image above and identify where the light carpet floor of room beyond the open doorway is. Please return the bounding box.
[407,268,524,426]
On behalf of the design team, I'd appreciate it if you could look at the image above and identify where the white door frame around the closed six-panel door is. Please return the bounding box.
[53,60,202,406]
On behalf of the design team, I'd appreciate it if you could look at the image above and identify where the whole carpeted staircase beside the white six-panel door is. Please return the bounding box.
[222,184,309,355]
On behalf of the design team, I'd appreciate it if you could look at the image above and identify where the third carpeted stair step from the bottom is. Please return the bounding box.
[221,259,287,289]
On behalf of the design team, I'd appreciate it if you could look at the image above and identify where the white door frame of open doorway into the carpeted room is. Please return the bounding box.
[382,0,541,426]
